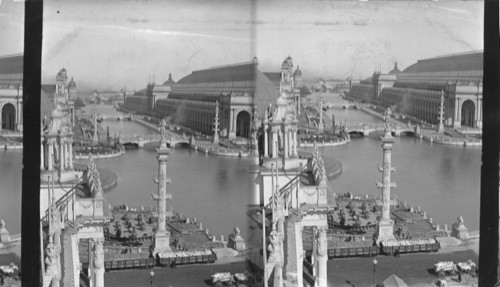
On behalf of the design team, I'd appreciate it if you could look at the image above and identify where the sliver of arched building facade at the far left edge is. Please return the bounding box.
[0,54,23,132]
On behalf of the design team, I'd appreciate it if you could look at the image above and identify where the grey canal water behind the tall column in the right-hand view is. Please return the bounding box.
[320,99,481,231]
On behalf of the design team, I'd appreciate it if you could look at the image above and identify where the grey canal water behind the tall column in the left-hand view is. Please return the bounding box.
[83,119,255,238]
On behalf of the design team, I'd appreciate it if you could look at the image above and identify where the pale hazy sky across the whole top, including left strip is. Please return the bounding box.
[0,0,483,90]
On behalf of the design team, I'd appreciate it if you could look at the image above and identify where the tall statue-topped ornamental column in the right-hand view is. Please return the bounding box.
[376,120,396,243]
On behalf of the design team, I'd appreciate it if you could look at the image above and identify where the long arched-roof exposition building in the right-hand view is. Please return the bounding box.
[349,51,483,128]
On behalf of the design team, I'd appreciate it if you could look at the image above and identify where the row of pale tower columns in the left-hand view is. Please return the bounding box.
[40,139,73,171]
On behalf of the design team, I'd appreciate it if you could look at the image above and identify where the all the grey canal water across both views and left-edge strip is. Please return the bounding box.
[0,100,481,236]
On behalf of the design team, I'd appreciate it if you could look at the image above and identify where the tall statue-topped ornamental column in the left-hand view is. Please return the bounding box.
[152,120,172,255]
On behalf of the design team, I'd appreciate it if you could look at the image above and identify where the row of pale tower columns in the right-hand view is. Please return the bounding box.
[264,125,298,158]
